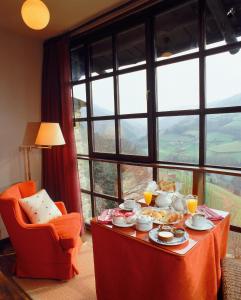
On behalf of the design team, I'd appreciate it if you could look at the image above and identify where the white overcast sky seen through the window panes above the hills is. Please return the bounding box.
[73,39,241,117]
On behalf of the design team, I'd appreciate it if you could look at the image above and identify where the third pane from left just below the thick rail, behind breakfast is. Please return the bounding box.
[121,165,153,200]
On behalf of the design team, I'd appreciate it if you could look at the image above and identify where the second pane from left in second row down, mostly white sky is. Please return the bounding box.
[92,77,114,116]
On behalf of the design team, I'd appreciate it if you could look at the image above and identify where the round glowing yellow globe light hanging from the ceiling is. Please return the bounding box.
[21,0,50,30]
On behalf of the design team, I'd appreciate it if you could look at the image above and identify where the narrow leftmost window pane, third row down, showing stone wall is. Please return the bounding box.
[74,122,89,155]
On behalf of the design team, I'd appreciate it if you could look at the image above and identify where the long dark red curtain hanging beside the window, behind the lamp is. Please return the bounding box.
[42,37,81,219]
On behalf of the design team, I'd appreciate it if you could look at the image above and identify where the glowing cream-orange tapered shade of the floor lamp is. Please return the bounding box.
[35,123,65,146]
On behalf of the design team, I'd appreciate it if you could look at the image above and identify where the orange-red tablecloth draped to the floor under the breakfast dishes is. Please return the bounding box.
[91,215,230,300]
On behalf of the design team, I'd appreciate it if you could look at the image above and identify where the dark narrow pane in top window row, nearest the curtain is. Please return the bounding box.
[70,46,85,81]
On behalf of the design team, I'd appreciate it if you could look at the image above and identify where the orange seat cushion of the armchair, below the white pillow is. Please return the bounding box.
[49,213,81,249]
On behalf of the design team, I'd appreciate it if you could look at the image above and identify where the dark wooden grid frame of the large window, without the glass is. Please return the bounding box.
[70,0,241,231]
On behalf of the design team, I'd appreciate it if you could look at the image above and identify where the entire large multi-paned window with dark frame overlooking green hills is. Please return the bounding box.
[71,0,241,227]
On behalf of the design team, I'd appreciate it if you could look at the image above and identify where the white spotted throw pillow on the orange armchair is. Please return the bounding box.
[19,189,62,224]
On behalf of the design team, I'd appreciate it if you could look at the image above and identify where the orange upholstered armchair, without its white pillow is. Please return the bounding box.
[0,181,81,280]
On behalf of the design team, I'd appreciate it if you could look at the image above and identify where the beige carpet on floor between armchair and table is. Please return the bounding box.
[13,235,96,300]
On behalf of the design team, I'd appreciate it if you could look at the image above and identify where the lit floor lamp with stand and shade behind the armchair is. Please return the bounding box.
[20,122,65,180]
